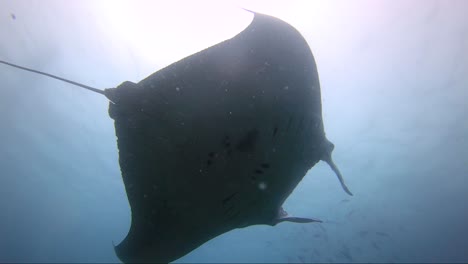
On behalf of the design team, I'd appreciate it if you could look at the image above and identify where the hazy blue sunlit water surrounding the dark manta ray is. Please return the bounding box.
[0,0,468,263]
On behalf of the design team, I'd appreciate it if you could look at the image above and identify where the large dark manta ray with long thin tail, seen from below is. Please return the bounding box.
[1,9,351,262]
